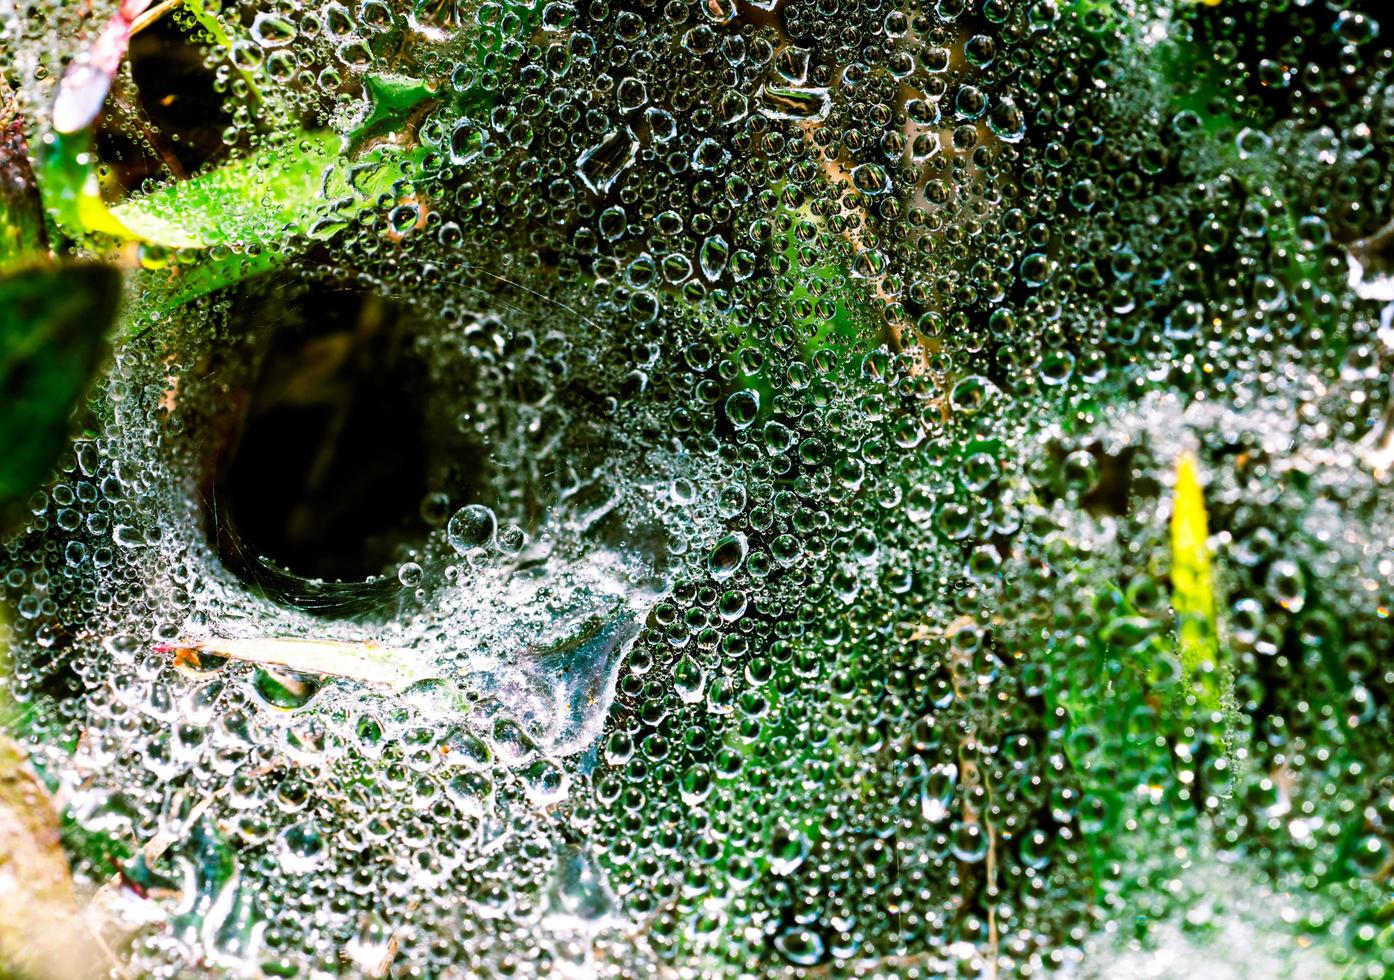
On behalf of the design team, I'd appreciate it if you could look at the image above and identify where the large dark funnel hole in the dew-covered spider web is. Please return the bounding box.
[213,290,478,615]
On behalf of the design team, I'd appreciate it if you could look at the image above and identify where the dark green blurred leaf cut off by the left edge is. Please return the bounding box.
[0,263,121,530]
